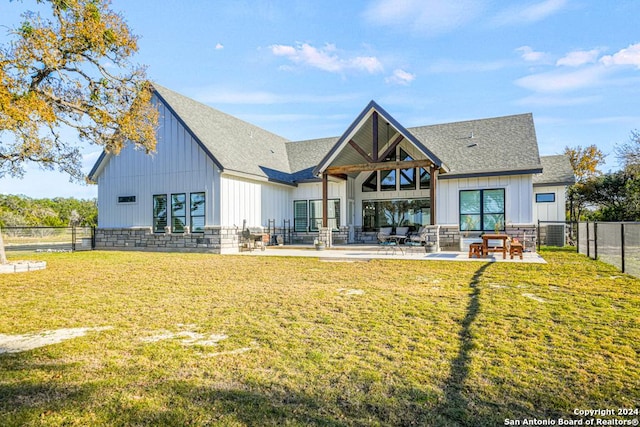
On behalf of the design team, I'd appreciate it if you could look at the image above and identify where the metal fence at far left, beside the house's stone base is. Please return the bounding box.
[0,227,95,251]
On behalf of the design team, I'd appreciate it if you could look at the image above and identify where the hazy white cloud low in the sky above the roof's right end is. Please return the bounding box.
[516,66,606,93]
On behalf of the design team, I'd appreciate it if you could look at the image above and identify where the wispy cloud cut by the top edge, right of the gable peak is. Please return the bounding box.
[364,0,484,35]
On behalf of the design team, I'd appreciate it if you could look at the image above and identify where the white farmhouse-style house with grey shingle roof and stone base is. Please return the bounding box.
[89,85,573,253]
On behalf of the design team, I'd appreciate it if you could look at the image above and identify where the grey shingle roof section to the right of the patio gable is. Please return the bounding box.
[408,114,542,178]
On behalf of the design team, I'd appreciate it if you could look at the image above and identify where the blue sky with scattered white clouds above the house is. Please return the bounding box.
[0,0,640,198]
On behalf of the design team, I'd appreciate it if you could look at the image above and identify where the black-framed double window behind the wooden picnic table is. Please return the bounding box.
[460,188,505,231]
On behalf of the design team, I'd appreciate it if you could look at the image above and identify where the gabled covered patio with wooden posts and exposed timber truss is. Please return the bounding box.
[313,101,448,247]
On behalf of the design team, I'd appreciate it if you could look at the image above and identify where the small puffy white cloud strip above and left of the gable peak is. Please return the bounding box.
[270,43,384,74]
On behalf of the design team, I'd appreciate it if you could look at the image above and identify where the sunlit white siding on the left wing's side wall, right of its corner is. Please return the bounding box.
[220,173,293,227]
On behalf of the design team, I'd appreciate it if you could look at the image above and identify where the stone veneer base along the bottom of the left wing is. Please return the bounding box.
[96,226,241,254]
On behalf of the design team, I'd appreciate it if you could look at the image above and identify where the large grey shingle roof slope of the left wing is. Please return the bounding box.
[154,84,291,179]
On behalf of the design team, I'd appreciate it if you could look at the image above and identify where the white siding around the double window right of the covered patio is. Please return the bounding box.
[436,175,534,226]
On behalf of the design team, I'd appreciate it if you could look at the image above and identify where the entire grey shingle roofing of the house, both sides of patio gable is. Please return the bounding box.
[91,84,552,184]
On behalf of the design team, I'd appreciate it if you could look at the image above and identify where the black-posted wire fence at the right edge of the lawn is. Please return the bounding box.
[578,222,640,277]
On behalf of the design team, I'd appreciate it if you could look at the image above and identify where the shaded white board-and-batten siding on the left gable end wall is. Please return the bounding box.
[98,103,220,228]
